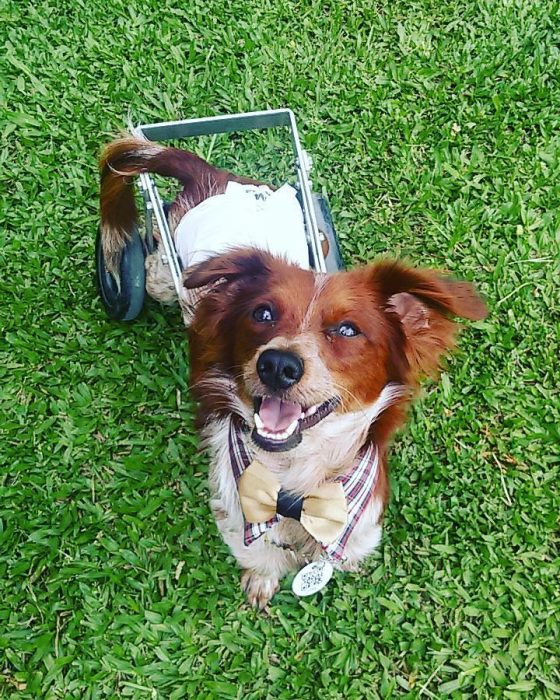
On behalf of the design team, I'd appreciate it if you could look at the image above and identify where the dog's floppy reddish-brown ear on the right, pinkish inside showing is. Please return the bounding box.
[373,263,488,375]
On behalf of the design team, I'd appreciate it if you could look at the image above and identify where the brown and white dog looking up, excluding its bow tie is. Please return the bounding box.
[101,138,486,607]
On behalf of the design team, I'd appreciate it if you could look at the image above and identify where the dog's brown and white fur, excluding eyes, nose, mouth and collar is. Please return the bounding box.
[101,138,486,606]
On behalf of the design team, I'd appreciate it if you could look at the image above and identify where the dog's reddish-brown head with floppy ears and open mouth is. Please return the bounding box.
[185,249,486,452]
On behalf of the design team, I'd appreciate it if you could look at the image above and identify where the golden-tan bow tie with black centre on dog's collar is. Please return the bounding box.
[238,461,348,544]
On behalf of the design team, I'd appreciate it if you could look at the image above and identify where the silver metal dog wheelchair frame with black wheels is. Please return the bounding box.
[96,109,344,321]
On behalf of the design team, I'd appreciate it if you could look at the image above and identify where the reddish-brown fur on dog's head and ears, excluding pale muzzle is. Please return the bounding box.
[186,250,486,502]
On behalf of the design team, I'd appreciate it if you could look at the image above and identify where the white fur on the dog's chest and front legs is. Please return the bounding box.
[201,385,403,576]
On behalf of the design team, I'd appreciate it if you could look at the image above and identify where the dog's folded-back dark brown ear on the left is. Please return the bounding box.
[183,248,271,289]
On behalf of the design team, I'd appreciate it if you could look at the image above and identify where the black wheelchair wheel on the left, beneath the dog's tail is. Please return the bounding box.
[95,228,146,321]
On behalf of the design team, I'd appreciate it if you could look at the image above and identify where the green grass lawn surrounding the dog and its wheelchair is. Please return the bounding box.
[0,0,560,700]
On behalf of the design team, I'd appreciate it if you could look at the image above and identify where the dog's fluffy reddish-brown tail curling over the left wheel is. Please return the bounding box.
[99,136,225,274]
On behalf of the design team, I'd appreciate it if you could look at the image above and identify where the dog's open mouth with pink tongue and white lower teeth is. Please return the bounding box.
[251,396,340,452]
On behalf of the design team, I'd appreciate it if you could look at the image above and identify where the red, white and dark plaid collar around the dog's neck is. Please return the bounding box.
[228,419,379,561]
